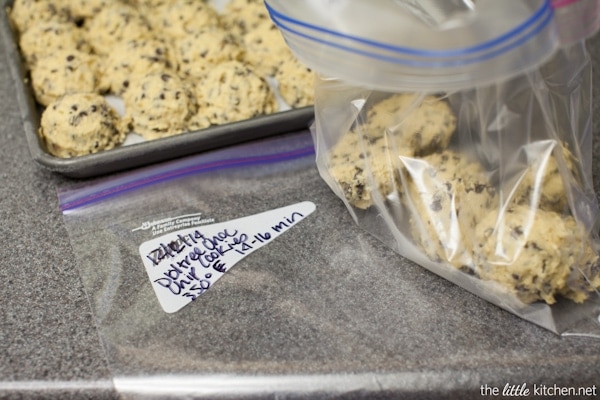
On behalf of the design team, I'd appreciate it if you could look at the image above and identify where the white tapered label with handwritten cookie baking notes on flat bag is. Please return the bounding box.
[139,201,316,313]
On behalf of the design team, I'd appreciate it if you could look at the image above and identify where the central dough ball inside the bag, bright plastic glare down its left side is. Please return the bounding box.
[402,150,498,268]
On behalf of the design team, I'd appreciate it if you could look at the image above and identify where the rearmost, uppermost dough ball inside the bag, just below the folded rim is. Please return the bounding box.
[365,93,456,155]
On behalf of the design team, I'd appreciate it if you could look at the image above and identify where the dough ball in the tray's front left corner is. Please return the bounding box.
[40,93,125,158]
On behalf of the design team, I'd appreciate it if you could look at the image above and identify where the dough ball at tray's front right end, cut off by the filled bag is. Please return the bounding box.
[275,53,315,108]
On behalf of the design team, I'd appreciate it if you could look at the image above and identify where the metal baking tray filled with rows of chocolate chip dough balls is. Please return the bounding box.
[0,0,314,178]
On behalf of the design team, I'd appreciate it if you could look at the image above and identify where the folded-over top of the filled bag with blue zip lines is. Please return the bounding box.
[265,0,559,91]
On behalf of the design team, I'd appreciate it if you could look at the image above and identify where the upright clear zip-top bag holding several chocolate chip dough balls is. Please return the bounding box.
[266,0,600,335]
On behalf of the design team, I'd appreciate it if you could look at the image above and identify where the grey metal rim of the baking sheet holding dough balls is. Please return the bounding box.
[0,0,314,178]
